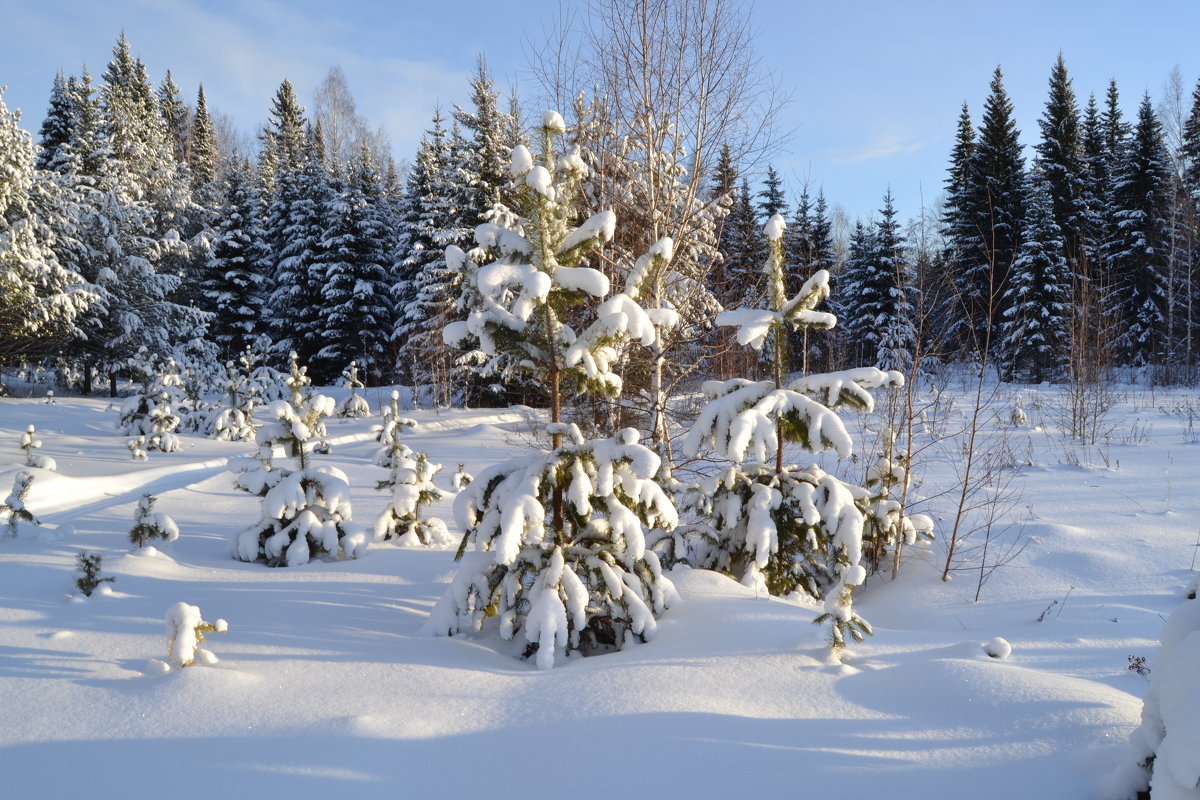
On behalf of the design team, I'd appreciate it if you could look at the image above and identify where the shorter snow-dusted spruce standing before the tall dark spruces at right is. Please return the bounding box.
[1002,172,1072,383]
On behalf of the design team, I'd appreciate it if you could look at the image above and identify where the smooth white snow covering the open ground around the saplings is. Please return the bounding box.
[0,387,1200,800]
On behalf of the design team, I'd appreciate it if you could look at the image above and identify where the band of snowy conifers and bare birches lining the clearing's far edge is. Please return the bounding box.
[0,17,1200,405]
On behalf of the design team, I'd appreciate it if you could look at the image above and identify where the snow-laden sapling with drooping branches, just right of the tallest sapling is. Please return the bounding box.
[684,215,904,646]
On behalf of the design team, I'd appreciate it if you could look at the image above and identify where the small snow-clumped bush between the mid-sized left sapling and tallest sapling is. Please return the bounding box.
[374,445,452,545]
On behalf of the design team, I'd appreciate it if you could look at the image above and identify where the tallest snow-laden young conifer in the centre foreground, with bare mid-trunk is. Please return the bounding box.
[430,112,677,668]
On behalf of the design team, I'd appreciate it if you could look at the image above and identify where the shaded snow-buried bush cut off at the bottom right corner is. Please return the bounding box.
[1111,600,1200,800]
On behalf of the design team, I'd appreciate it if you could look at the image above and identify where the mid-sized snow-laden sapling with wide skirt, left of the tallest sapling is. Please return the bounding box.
[232,353,368,566]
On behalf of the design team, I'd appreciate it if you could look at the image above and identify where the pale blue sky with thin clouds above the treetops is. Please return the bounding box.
[0,0,1200,217]
